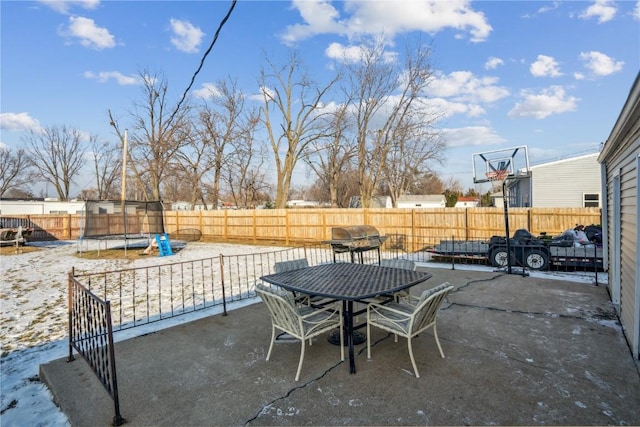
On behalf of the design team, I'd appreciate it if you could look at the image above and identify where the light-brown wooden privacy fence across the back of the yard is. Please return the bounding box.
[0,208,601,245]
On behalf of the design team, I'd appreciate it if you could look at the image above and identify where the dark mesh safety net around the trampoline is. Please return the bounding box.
[81,200,164,239]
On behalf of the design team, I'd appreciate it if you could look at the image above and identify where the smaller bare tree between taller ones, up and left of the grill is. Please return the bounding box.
[304,103,356,208]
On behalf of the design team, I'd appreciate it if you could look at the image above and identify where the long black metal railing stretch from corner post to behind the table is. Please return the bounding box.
[73,245,333,331]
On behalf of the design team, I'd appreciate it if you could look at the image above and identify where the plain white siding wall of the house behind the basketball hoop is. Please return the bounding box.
[531,153,602,208]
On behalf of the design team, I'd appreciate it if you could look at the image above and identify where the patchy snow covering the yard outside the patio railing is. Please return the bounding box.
[0,241,607,427]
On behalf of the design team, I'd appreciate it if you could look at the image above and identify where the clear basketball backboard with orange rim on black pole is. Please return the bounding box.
[472,145,529,184]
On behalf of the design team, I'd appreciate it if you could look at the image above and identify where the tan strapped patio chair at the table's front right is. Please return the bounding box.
[367,282,453,378]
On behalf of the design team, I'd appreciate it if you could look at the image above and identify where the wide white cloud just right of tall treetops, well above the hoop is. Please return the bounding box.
[429,71,509,103]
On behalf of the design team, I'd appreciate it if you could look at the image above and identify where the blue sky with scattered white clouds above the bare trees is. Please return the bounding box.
[0,0,640,196]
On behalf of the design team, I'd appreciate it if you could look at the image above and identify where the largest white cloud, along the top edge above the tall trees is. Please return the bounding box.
[282,0,492,44]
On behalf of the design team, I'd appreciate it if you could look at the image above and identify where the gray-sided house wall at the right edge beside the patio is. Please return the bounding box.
[598,73,640,360]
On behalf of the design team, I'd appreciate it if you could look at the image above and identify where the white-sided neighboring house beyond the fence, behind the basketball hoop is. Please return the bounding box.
[507,153,602,208]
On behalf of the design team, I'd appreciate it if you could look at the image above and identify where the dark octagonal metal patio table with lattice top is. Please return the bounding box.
[261,263,431,374]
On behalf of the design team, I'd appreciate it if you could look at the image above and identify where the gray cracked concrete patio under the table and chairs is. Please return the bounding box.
[40,269,640,426]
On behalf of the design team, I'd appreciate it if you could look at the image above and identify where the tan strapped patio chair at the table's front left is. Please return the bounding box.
[256,283,344,381]
